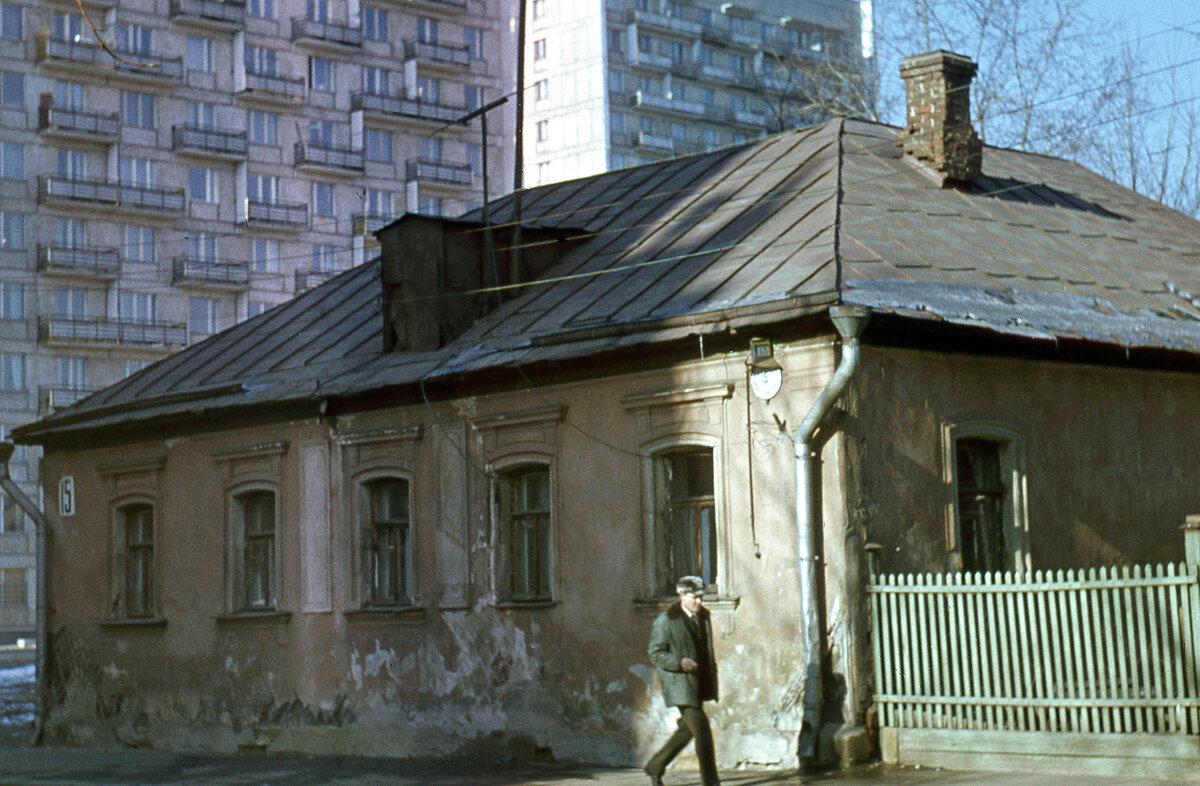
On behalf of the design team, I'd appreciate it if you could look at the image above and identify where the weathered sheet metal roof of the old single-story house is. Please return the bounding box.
[17,120,1200,439]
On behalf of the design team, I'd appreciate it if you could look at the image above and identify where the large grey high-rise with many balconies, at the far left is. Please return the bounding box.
[0,0,516,631]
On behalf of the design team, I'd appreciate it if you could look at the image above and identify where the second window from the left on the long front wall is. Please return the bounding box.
[232,490,276,611]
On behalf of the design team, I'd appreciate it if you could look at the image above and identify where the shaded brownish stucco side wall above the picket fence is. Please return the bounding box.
[845,348,1200,572]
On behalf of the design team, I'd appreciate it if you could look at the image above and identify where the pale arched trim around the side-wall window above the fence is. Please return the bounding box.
[942,419,1033,571]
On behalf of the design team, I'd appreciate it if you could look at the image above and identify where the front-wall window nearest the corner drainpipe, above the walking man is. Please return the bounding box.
[653,446,716,595]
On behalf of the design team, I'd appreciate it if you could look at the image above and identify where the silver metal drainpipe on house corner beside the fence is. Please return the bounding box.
[796,306,869,764]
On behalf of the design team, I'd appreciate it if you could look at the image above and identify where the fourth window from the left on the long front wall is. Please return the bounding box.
[493,464,551,601]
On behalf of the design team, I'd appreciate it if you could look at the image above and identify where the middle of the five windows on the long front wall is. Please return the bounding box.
[359,478,413,606]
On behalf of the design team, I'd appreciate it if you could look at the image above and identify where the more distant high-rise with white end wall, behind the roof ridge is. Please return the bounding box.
[523,0,874,185]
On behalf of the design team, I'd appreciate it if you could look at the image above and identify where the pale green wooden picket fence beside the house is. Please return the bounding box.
[869,559,1200,734]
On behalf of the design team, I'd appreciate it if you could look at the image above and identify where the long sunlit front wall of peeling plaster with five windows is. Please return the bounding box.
[43,342,846,767]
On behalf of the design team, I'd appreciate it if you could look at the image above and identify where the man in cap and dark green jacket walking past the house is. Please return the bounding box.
[644,576,720,786]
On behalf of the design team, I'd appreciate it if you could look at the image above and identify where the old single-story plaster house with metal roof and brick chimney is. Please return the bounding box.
[14,52,1200,766]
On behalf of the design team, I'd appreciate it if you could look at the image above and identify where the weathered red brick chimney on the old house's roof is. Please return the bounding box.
[900,49,983,186]
